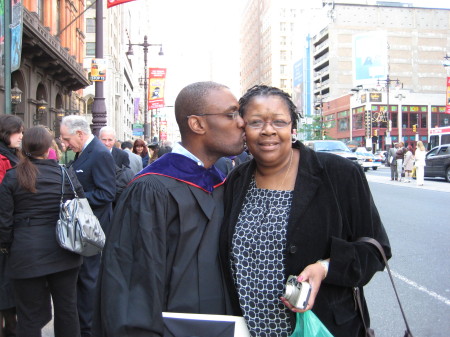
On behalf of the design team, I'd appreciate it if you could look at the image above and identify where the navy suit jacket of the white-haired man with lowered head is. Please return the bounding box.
[71,137,116,234]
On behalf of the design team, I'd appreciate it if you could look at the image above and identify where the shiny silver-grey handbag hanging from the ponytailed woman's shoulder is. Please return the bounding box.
[56,165,105,256]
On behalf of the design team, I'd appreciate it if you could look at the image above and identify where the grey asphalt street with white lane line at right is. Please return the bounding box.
[43,167,450,337]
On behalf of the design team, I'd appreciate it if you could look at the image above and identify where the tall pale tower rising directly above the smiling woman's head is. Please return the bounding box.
[240,0,312,94]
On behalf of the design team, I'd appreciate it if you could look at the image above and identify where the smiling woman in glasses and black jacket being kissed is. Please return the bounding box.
[221,85,390,337]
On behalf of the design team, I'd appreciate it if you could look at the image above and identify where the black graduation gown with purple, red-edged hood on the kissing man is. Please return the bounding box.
[94,153,229,337]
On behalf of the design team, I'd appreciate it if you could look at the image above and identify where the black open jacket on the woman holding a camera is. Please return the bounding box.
[220,142,391,337]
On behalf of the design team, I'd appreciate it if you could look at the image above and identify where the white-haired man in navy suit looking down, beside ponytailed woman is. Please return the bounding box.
[60,116,116,337]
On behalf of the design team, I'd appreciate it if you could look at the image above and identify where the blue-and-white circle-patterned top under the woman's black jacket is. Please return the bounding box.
[231,179,293,337]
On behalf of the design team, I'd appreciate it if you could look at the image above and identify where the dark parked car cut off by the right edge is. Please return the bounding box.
[425,144,450,182]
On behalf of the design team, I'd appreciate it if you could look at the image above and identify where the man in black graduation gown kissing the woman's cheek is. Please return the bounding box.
[94,82,244,337]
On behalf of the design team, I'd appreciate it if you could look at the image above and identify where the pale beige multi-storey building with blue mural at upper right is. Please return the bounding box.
[312,1,450,100]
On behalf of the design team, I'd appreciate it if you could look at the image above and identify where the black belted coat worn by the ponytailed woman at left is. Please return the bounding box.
[0,159,84,279]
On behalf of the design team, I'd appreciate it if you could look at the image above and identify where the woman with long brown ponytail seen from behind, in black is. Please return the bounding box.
[0,126,84,337]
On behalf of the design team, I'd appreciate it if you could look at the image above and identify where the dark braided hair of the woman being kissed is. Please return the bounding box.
[239,84,299,129]
